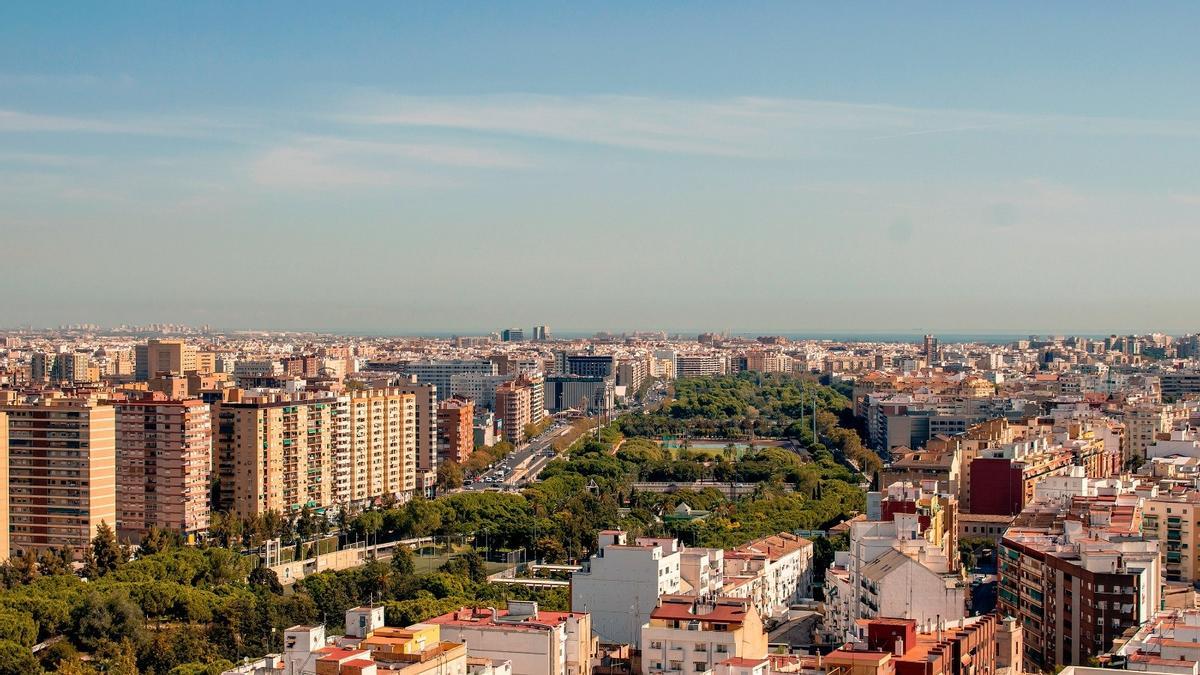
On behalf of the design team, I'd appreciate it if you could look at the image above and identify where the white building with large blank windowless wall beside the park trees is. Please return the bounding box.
[571,530,698,649]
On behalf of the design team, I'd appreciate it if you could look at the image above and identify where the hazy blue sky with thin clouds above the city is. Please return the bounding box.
[0,2,1200,333]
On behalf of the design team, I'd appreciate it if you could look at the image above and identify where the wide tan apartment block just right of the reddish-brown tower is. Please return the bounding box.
[212,389,347,518]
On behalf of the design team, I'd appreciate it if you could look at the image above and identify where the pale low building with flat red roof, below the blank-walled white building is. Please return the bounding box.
[425,601,596,675]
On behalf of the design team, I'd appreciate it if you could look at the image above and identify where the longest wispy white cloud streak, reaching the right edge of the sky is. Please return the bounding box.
[336,94,1200,157]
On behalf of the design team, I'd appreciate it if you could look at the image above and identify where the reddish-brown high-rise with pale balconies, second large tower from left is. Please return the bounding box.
[116,393,212,540]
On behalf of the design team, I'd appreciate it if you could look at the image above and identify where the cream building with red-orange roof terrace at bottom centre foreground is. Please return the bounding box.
[641,596,767,675]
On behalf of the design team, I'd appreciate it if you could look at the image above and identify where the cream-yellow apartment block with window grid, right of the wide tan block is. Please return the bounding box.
[348,388,418,506]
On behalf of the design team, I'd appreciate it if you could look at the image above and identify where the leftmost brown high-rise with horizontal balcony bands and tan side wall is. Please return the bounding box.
[0,399,116,552]
